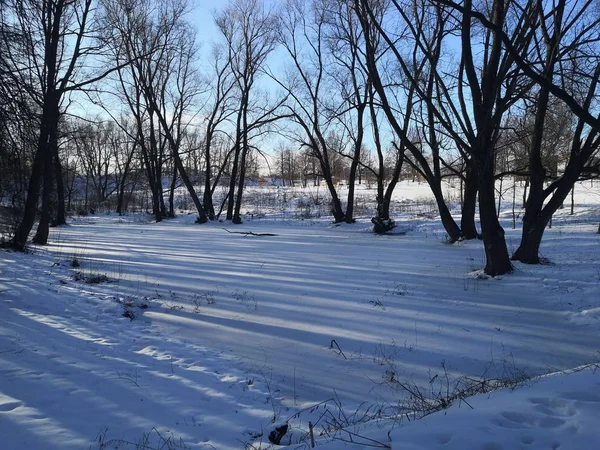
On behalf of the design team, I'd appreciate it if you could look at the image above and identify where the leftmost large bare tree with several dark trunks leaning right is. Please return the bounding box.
[2,0,119,250]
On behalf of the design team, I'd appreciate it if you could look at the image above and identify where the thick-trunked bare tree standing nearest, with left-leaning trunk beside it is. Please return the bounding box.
[356,0,532,275]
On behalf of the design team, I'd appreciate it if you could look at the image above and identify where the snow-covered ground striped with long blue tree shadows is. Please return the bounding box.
[0,181,600,450]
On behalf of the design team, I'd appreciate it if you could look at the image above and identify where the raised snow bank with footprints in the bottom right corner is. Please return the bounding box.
[392,369,600,450]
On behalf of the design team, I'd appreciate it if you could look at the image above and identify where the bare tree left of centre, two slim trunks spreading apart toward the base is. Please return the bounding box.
[107,0,207,223]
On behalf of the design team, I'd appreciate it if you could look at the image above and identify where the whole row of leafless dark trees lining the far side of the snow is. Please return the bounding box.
[0,0,600,276]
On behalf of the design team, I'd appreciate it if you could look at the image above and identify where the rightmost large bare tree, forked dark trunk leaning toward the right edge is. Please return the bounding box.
[512,1,600,264]
